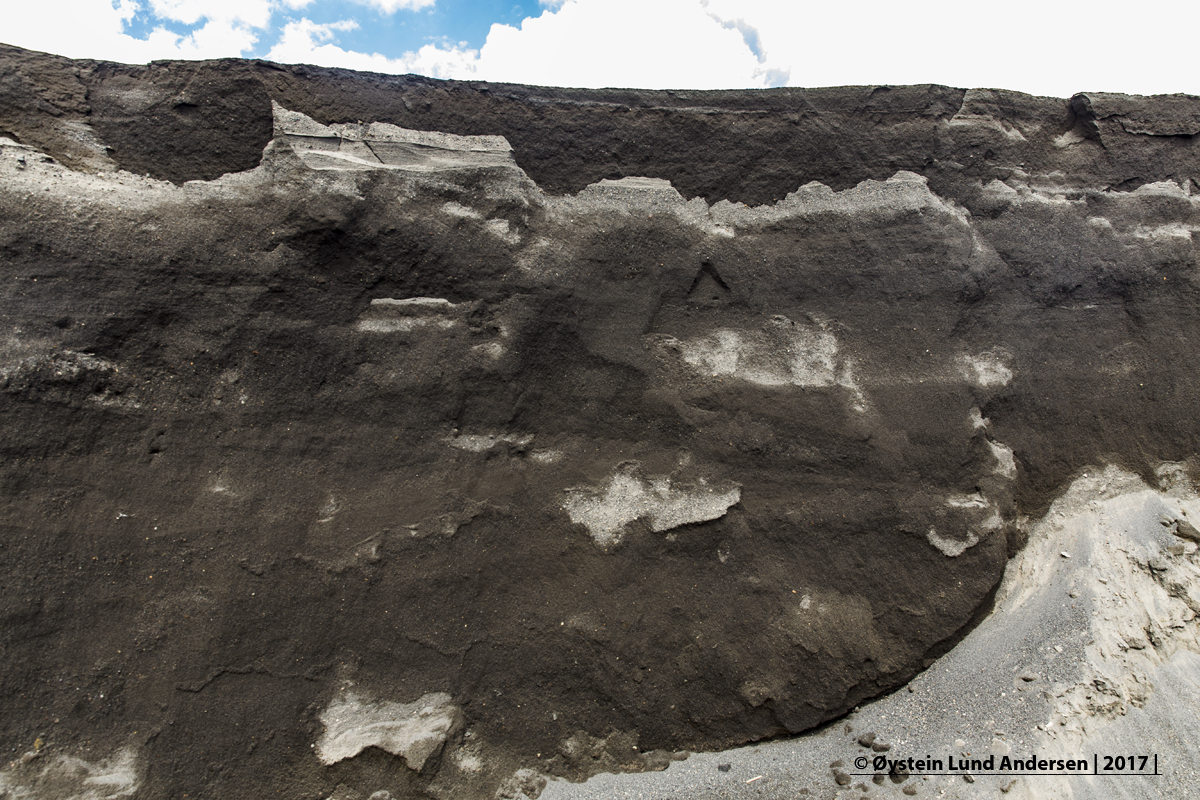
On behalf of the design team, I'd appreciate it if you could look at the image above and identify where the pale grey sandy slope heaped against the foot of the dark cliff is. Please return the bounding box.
[541,465,1200,800]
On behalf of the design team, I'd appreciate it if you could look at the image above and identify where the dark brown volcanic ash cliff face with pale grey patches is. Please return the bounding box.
[0,47,1200,800]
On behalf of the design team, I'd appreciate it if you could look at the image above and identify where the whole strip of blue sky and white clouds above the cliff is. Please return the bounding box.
[0,0,1200,97]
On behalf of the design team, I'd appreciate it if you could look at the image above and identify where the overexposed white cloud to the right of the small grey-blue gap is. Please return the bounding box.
[703,0,1200,97]
